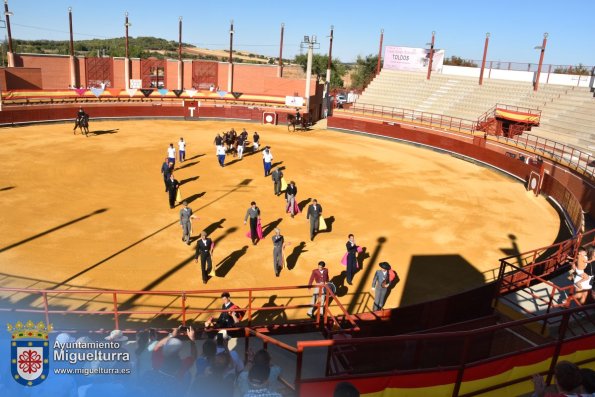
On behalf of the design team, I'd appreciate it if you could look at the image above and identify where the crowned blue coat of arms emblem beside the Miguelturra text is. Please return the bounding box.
[7,320,52,386]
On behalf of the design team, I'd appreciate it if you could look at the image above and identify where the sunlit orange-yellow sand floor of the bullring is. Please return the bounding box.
[0,120,560,326]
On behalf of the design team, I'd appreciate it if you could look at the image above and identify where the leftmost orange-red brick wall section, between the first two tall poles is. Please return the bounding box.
[14,54,70,90]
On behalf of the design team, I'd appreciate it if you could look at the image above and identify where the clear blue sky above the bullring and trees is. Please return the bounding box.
[4,0,595,65]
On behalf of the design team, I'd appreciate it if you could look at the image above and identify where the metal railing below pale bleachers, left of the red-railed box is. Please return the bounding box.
[344,102,477,134]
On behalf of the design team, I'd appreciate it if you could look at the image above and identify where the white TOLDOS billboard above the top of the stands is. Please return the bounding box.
[383,46,444,72]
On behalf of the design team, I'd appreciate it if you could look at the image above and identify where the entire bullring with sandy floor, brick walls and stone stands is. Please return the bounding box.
[0,6,595,397]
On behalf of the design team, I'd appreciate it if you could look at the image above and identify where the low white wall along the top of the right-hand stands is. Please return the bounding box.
[442,64,595,88]
